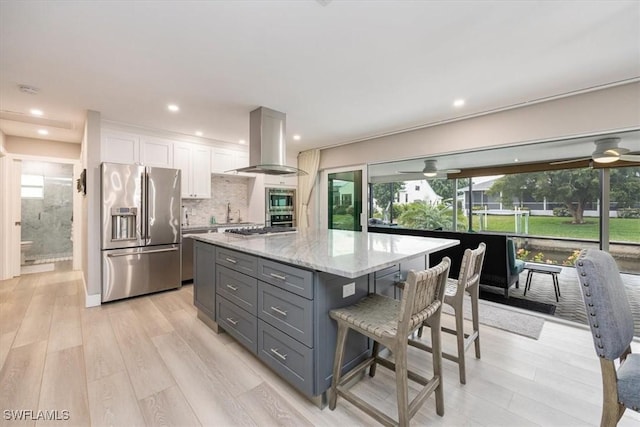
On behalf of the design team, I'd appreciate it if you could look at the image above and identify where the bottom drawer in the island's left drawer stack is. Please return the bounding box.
[216,297,258,354]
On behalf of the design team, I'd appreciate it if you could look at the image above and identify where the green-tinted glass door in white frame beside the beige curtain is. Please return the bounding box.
[325,168,366,231]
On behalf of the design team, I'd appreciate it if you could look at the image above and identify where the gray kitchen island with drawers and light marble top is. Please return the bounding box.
[193,230,459,406]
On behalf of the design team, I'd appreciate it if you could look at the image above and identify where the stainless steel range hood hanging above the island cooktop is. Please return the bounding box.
[236,107,307,175]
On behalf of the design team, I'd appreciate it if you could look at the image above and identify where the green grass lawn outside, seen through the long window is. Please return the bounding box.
[473,215,640,243]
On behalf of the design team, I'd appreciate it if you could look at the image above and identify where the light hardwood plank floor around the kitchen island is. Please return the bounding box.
[0,270,640,426]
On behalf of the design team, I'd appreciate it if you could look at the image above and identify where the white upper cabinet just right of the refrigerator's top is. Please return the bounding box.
[173,142,211,199]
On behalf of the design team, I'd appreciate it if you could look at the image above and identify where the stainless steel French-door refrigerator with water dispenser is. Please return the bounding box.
[100,163,181,302]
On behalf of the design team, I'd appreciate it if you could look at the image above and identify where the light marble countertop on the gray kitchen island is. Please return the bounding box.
[192,229,460,278]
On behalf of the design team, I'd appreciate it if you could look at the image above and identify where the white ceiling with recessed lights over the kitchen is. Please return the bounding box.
[0,0,640,166]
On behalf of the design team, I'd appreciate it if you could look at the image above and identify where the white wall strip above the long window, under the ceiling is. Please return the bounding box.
[310,83,640,231]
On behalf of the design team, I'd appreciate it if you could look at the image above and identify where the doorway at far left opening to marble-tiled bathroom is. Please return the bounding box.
[20,160,73,274]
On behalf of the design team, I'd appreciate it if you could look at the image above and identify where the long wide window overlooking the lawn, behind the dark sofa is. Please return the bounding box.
[369,162,640,273]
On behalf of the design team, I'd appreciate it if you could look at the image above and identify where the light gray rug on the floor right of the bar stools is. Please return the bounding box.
[442,298,544,340]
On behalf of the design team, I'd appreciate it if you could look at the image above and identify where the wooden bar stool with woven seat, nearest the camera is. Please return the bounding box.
[329,257,451,426]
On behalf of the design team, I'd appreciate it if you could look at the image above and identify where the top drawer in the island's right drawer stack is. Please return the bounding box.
[258,258,313,299]
